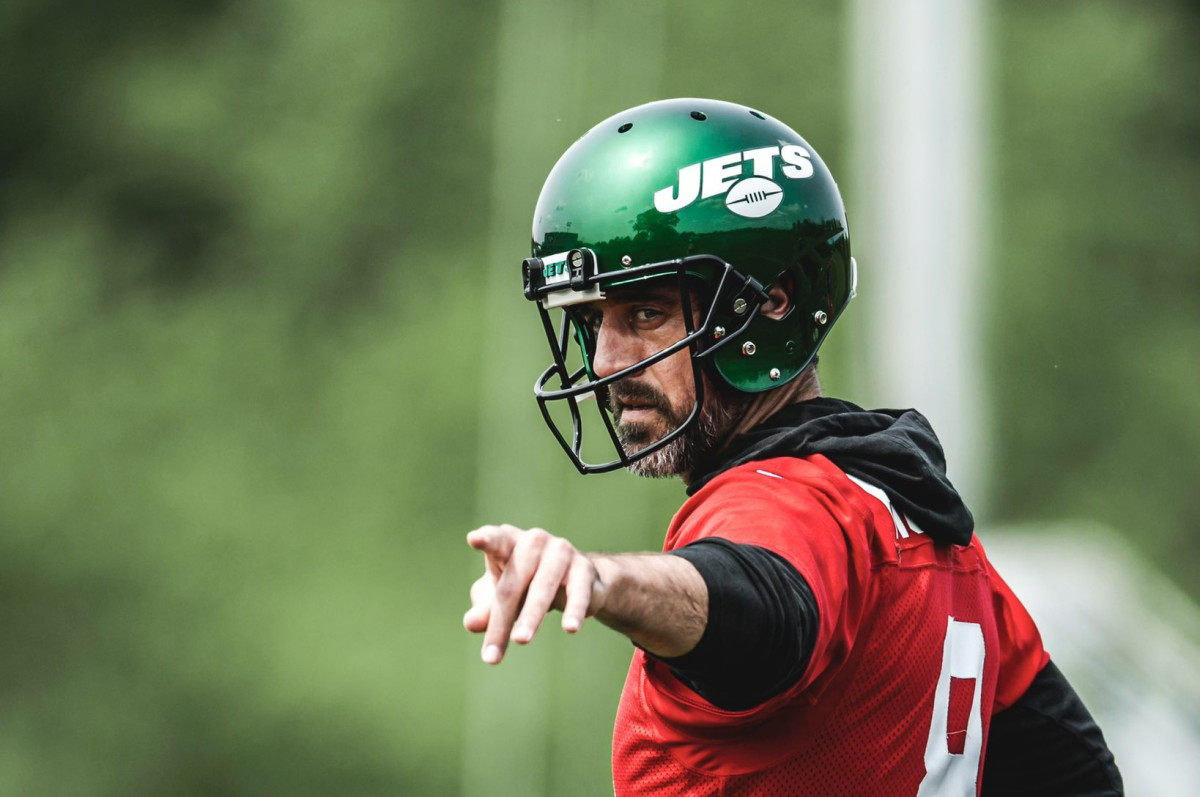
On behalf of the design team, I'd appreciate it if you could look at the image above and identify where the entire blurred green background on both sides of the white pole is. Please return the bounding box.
[0,0,1200,796]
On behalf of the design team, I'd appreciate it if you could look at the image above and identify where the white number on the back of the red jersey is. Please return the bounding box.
[917,617,984,797]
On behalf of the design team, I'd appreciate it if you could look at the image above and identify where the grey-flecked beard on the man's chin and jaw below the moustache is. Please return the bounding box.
[617,380,750,479]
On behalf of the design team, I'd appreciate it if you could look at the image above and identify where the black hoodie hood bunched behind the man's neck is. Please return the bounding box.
[688,397,974,545]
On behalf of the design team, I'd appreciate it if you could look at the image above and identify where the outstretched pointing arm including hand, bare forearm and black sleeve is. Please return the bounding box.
[463,526,818,711]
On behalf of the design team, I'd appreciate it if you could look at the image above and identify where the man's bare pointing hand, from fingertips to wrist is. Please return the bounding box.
[462,525,605,664]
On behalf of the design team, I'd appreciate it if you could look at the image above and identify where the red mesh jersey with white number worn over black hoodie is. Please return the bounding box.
[613,455,1048,797]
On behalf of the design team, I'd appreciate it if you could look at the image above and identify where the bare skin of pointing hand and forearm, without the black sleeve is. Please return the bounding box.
[463,526,708,664]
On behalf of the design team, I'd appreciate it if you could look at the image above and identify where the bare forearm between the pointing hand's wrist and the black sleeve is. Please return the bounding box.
[589,553,708,658]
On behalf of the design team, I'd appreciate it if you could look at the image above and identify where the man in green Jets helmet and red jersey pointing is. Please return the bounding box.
[464,100,1122,797]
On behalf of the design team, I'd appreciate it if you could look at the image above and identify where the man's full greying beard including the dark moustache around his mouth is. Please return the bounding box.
[608,374,752,479]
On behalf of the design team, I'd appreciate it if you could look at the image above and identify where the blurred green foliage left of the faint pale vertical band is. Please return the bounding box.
[0,2,491,795]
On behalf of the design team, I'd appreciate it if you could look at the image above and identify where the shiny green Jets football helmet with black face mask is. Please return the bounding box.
[522,100,856,473]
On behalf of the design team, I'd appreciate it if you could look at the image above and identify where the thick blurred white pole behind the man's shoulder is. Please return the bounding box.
[850,0,989,514]
